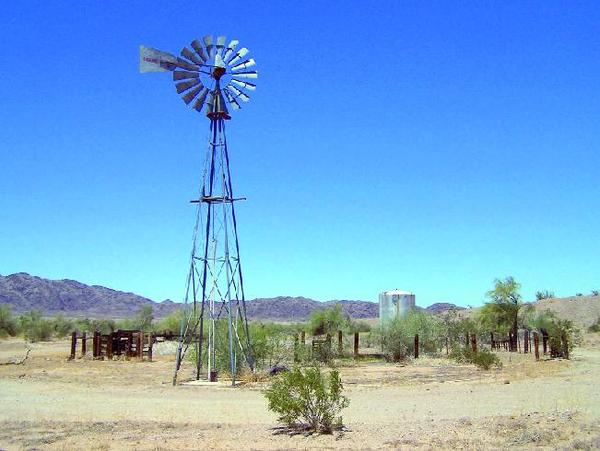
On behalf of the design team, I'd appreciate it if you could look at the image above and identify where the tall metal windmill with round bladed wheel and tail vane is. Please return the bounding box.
[140,35,258,385]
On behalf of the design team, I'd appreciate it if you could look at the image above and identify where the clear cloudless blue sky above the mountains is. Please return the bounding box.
[0,1,600,305]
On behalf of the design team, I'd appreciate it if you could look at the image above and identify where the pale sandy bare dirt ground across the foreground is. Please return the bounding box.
[0,337,600,450]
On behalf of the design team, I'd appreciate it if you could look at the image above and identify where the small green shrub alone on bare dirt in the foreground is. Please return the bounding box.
[265,367,349,433]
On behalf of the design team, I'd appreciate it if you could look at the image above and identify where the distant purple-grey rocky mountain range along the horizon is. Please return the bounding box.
[0,273,454,321]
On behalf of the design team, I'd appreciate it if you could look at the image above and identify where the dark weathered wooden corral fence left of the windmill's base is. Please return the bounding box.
[70,329,179,362]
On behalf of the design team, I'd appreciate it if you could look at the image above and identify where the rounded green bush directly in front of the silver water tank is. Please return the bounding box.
[382,310,444,362]
